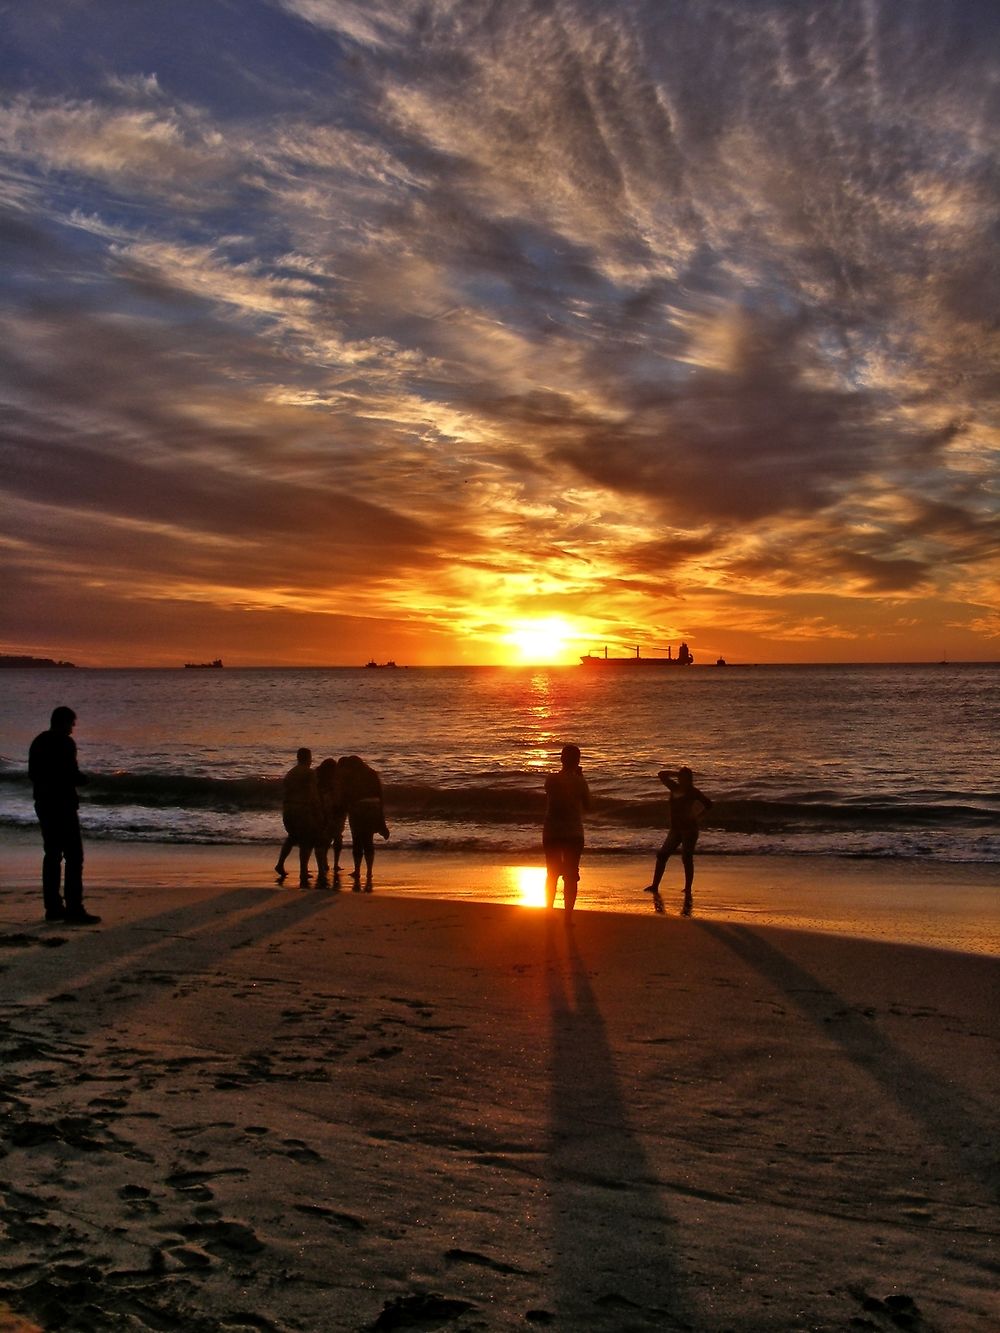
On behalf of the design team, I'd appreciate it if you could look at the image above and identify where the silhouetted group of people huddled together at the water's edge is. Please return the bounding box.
[282,746,389,890]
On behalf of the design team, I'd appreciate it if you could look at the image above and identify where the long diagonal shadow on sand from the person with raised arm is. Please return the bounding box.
[697,921,1000,1194]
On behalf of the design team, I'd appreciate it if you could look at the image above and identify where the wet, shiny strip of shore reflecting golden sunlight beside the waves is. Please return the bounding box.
[0,829,1000,957]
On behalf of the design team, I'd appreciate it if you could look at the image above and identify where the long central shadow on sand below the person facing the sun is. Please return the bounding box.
[545,920,691,1333]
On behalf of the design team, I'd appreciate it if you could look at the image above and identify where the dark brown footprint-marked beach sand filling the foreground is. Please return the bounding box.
[0,868,1000,1333]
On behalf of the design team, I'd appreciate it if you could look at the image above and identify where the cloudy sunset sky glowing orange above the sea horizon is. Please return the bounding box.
[0,0,1000,665]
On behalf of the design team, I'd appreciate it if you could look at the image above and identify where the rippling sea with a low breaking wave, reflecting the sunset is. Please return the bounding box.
[0,664,1000,864]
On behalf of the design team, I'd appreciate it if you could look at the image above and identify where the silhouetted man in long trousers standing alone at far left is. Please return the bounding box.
[28,706,100,925]
